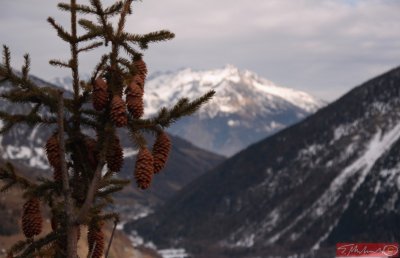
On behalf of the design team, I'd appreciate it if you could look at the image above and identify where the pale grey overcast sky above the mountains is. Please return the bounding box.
[0,0,400,100]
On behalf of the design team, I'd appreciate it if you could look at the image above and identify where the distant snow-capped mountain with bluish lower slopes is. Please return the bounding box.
[145,65,324,156]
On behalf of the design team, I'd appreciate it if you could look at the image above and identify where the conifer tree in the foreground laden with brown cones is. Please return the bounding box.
[0,0,215,258]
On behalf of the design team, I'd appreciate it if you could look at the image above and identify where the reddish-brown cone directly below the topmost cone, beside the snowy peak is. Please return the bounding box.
[126,82,144,119]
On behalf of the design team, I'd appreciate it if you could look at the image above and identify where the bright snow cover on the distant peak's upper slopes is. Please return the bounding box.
[145,65,324,118]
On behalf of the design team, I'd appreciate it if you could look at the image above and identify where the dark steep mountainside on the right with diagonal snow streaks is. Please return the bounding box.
[129,68,400,258]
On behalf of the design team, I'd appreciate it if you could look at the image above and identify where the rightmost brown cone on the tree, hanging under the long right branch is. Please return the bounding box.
[153,132,171,173]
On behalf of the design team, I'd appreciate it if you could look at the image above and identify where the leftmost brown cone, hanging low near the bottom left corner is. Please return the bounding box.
[22,198,43,238]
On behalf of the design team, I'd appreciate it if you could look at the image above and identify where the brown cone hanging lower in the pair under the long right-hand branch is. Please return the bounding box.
[135,148,154,189]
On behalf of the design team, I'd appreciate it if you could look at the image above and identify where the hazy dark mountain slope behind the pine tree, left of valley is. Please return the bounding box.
[0,76,225,207]
